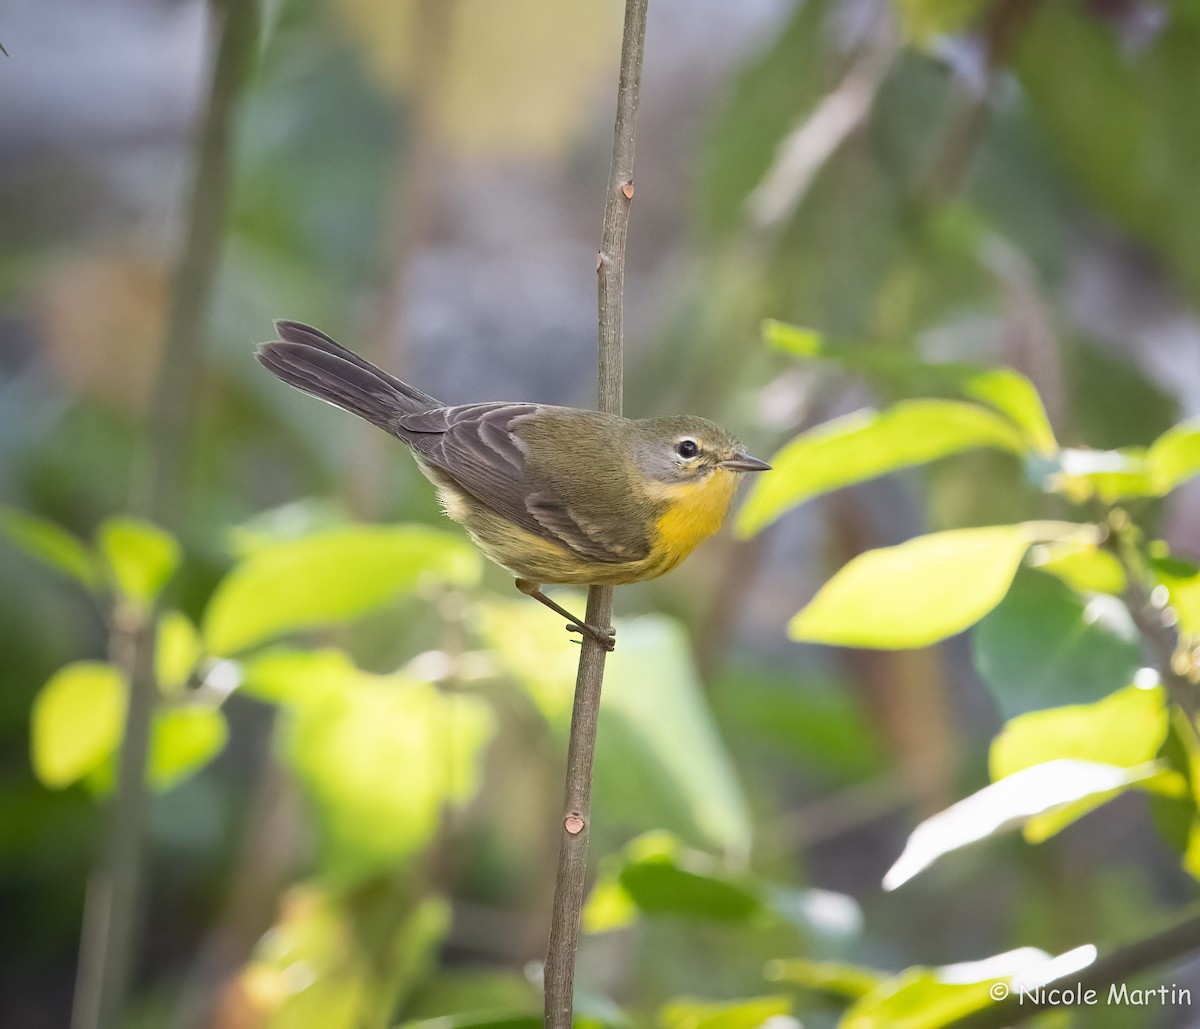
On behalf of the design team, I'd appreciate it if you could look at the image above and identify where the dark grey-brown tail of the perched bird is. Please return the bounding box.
[254,321,443,432]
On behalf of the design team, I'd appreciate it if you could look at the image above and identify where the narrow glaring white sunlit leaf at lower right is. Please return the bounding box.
[883,753,1159,890]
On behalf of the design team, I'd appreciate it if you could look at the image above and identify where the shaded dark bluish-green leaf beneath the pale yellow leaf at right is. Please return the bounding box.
[971,566,1141,719]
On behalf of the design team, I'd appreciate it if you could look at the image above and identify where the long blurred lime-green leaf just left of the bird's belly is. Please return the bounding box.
[204,525,480,655]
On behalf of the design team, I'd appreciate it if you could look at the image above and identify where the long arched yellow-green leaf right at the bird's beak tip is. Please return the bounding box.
[736,401,1027,537]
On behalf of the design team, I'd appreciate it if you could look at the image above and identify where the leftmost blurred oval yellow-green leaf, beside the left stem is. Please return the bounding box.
[31,661,128,789]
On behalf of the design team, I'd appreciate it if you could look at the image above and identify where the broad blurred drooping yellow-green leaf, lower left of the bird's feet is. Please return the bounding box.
[284,673,491,884]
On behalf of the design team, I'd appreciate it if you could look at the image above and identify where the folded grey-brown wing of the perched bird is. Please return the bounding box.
[394,403,649,564]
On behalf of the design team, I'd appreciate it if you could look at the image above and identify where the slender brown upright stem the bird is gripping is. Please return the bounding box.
[545,0,649,1029]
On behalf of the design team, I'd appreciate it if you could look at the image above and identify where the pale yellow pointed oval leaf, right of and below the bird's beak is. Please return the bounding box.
[788,525,1032,649]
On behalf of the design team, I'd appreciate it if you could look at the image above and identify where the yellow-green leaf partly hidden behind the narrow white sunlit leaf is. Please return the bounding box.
[989,686,1168,843]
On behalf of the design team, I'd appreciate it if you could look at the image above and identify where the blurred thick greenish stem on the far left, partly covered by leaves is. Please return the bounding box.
[71,0,258,1029]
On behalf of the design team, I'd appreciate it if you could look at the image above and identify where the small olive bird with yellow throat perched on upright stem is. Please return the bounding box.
[256,321,770,650]
